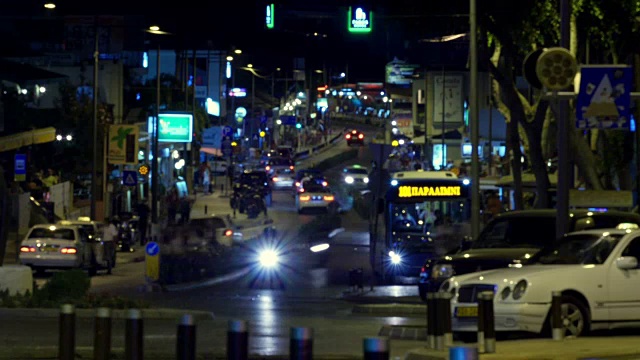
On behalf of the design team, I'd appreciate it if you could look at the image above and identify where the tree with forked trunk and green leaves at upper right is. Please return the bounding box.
[480,0,638,208]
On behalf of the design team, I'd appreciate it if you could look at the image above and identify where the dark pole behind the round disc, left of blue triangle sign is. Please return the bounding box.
[556,0,571,239]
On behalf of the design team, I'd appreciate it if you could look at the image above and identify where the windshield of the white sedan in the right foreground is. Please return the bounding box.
[529,233,622,265]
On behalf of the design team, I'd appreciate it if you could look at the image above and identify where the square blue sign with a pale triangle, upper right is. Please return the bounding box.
[576,65,633,129]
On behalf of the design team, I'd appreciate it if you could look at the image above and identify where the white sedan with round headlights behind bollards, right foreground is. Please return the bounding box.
[440,229,640,336]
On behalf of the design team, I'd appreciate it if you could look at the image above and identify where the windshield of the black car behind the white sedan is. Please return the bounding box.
[471,216,556,249]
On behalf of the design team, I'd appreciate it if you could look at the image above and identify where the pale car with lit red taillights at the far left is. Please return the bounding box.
[18,224,110,276]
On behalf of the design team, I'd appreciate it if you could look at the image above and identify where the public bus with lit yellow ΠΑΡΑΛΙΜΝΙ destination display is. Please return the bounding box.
[376,170,471,283]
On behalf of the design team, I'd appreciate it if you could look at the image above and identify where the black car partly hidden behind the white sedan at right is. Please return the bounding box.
[418,209,640,300]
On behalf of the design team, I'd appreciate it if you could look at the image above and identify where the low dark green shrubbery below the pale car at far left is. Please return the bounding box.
[0,269,149,309]
